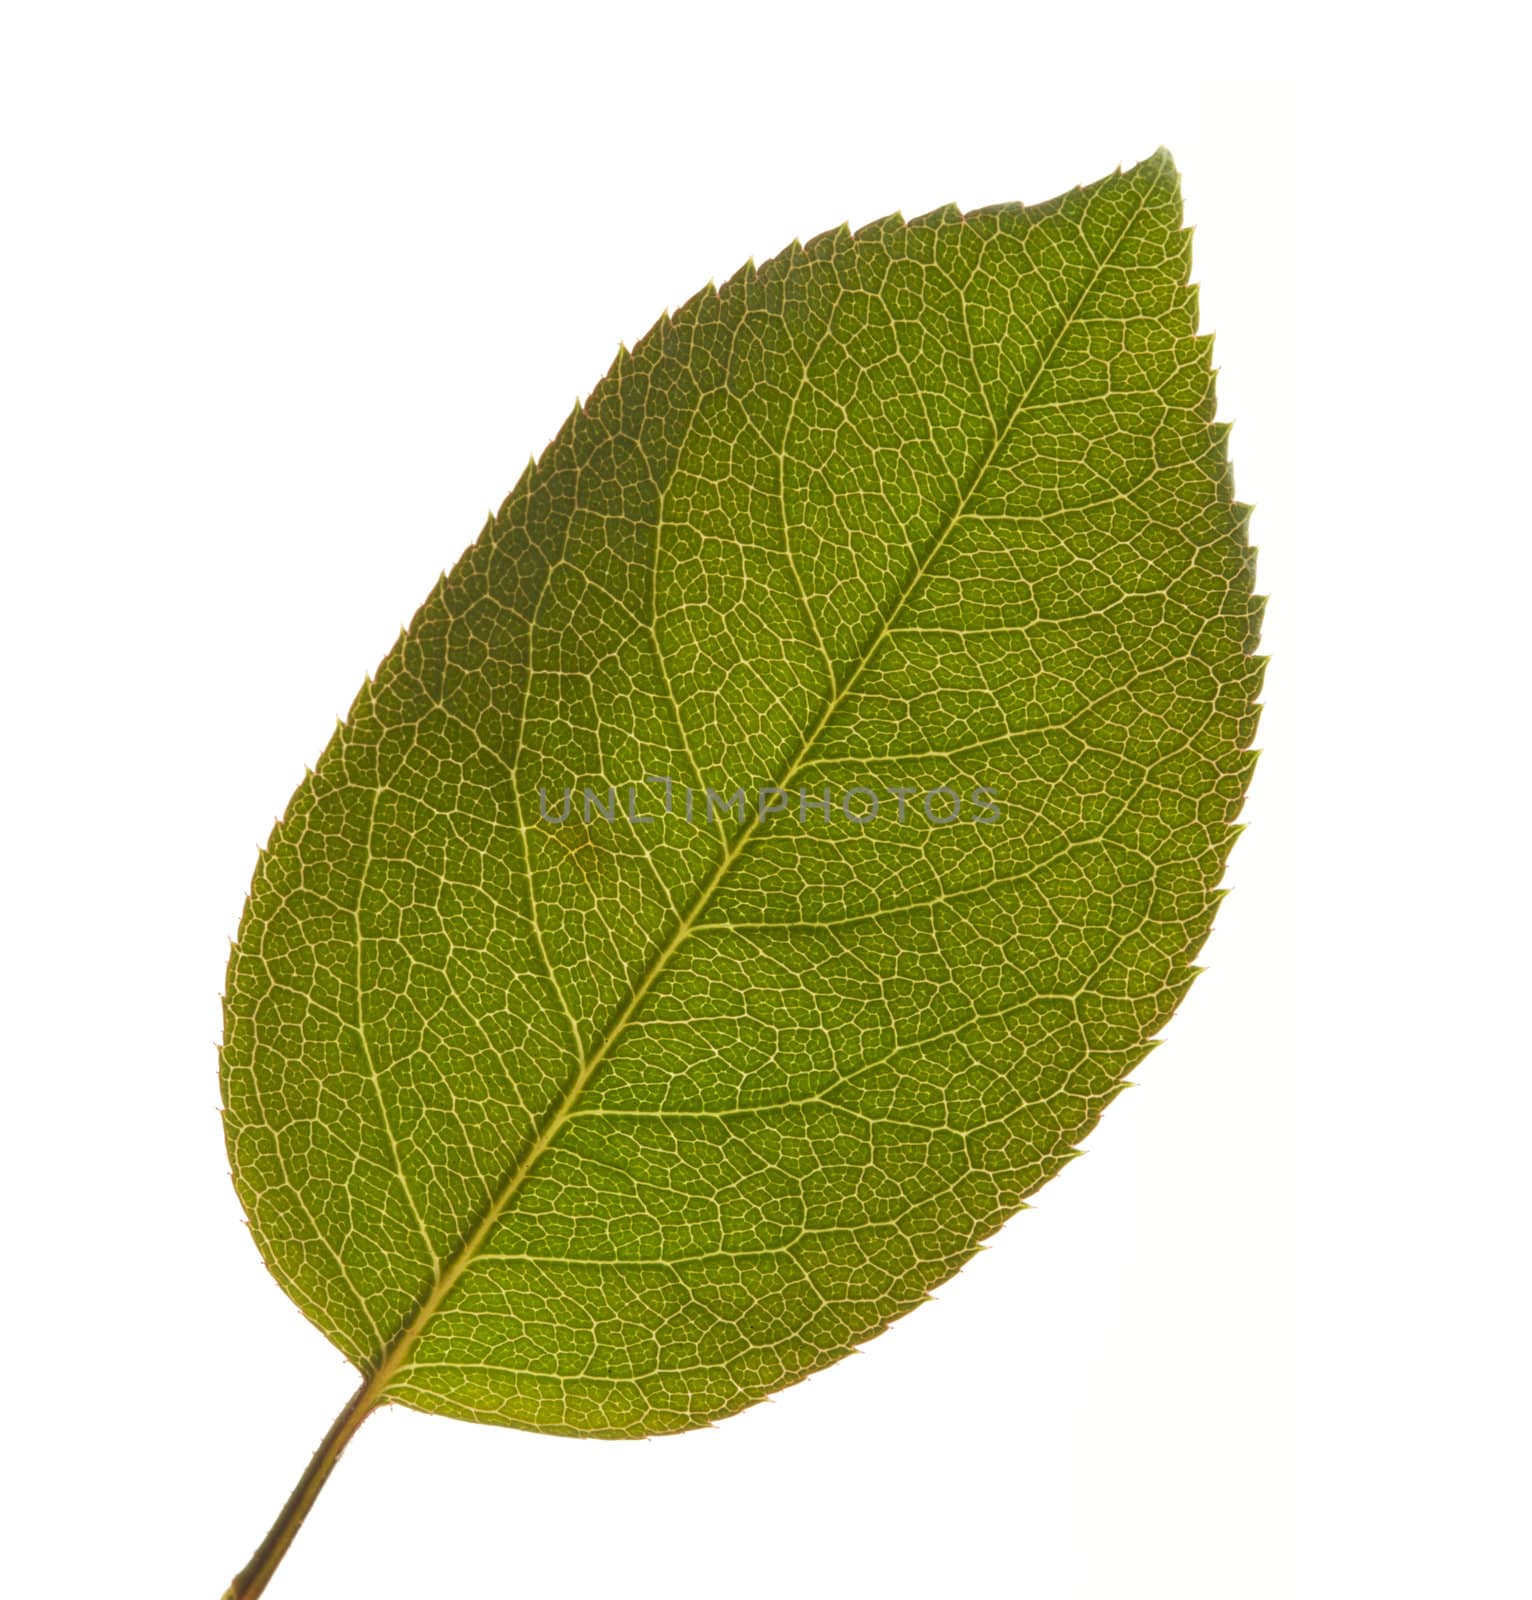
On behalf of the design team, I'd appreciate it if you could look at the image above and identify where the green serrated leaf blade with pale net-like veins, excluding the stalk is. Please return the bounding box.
[222,152,1260,1465]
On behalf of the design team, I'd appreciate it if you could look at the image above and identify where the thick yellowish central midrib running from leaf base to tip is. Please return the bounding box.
[365,195,1145,1405]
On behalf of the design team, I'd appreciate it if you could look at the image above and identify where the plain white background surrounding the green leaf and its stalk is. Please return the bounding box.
[0,0,1532,1600]
